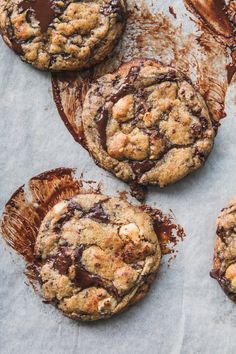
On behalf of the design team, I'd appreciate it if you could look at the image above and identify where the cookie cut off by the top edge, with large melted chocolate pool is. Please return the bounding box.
[0,0,126,71]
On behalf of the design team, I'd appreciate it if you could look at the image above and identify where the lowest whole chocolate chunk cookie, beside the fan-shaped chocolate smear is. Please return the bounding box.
[35,194,161,320]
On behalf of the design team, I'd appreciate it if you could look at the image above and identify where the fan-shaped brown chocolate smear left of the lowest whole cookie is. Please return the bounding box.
[1,168,101,285]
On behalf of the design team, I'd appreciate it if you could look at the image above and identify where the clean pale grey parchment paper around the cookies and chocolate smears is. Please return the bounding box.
[0,1,236,354]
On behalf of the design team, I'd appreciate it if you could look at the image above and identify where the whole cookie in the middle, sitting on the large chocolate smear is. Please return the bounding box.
[82,60,214,187]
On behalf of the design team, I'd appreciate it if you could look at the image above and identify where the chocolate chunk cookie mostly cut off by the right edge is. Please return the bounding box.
[211,198,236,302]
